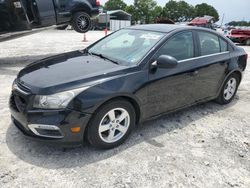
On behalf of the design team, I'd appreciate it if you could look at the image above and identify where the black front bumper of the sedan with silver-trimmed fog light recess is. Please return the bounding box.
[9,96,91,146]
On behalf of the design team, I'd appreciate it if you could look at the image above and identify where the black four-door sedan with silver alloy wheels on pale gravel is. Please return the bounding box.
[9,24,247,149]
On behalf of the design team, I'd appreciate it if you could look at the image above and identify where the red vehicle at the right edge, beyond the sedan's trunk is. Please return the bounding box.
[227,29,250,46]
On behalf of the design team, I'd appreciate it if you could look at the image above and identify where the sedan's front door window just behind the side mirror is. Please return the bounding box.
[156,32,194,60]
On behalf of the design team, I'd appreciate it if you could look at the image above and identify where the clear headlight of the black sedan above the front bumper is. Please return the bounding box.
[33,87,89,109]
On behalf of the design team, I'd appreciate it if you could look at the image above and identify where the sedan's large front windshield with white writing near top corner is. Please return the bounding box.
[88,29,163,66]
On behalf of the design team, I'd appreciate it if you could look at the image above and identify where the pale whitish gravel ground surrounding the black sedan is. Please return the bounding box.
[0,30,250,188]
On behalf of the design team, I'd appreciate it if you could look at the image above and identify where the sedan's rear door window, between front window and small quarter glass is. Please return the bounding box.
[198,32,220,55]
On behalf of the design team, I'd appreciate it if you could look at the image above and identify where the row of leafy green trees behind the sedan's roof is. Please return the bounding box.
[103,0,219,24]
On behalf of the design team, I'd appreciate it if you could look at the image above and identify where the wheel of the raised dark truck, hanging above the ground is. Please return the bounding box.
[71,12,92,33]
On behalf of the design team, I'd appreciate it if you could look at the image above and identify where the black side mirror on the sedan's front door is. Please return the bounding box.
[152,55,178,69]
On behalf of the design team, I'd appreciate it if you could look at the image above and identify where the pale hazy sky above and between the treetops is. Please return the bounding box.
[100,0,250,23]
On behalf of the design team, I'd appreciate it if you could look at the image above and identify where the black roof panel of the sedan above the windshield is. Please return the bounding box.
[129,24,196,33]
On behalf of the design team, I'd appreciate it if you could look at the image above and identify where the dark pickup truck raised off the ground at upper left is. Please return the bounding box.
[0,0,100,33]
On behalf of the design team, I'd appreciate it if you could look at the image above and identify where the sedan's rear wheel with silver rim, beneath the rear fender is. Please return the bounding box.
[216,73,240,105]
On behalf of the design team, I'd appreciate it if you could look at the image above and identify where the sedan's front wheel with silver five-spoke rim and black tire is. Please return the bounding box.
[87,100,135,149]
